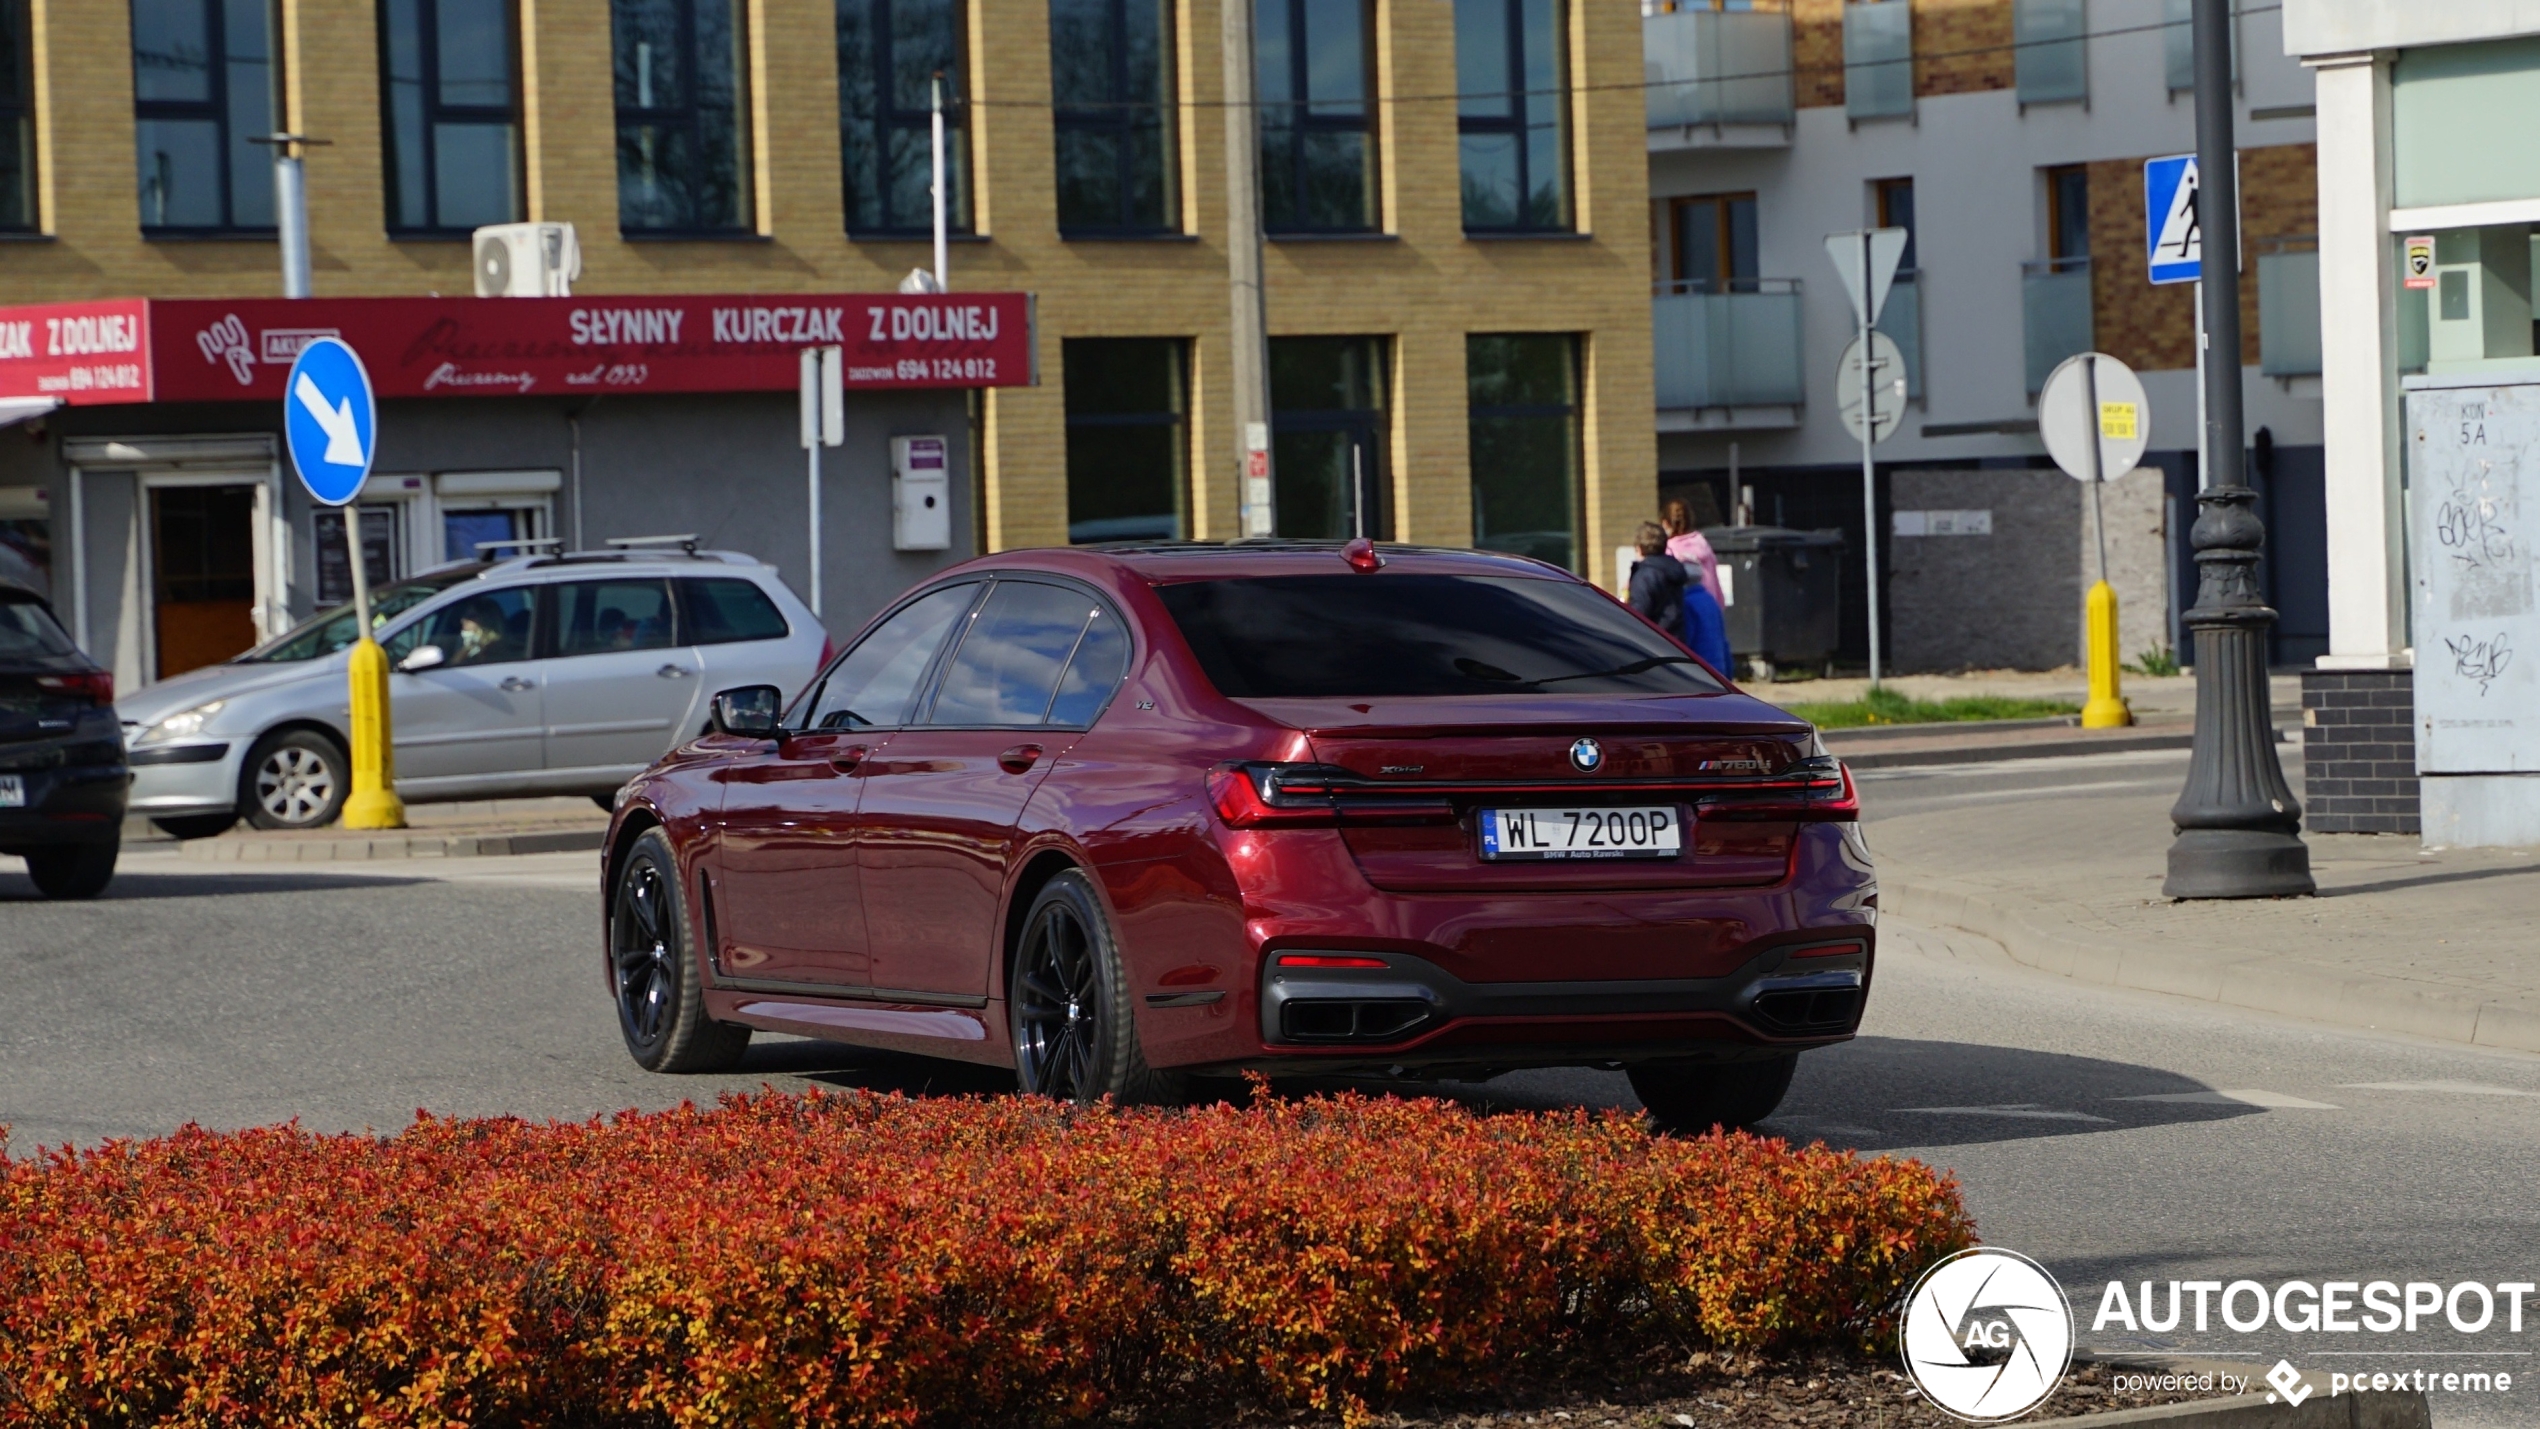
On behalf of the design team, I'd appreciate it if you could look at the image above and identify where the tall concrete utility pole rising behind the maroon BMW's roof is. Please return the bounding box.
[1219,0,1278,536]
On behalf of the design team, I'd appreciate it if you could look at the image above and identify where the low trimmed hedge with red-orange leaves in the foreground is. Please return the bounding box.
[0,1094,1971,1426]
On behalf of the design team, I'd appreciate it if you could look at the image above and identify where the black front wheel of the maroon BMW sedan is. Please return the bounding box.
[610,827,749,1074]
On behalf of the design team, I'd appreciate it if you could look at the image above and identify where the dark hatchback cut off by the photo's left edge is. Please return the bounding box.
[0,579,132,899]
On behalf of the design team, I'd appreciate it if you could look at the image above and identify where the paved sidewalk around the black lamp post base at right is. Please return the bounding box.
[1864,787,2540,1051]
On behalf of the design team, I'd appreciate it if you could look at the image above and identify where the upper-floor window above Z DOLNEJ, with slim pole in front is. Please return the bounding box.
[838,0,970,239]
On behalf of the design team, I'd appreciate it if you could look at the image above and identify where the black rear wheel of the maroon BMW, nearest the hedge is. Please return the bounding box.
[1006,868,1186,1107]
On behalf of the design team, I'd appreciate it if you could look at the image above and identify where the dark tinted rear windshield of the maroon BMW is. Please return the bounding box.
[1156,576,1722,698]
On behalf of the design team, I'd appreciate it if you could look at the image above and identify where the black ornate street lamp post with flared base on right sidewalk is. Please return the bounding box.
[2162,0,2314,899]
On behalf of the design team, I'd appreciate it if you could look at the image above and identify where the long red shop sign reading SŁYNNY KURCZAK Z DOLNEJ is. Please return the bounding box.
[0,292,1034,406]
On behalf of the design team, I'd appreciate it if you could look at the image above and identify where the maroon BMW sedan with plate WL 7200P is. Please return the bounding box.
[605,543,1877,1127]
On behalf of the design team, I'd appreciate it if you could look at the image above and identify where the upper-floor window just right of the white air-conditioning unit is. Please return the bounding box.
[610,0,752,236]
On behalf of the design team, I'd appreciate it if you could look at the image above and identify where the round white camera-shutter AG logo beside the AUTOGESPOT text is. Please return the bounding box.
[1905,1246,2073,1424]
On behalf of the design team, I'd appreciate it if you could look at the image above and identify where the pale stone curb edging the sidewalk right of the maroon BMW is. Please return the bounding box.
[1880,876,2540,1051]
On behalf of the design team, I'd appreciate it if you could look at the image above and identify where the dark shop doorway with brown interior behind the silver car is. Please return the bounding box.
[150,482,257,680]
